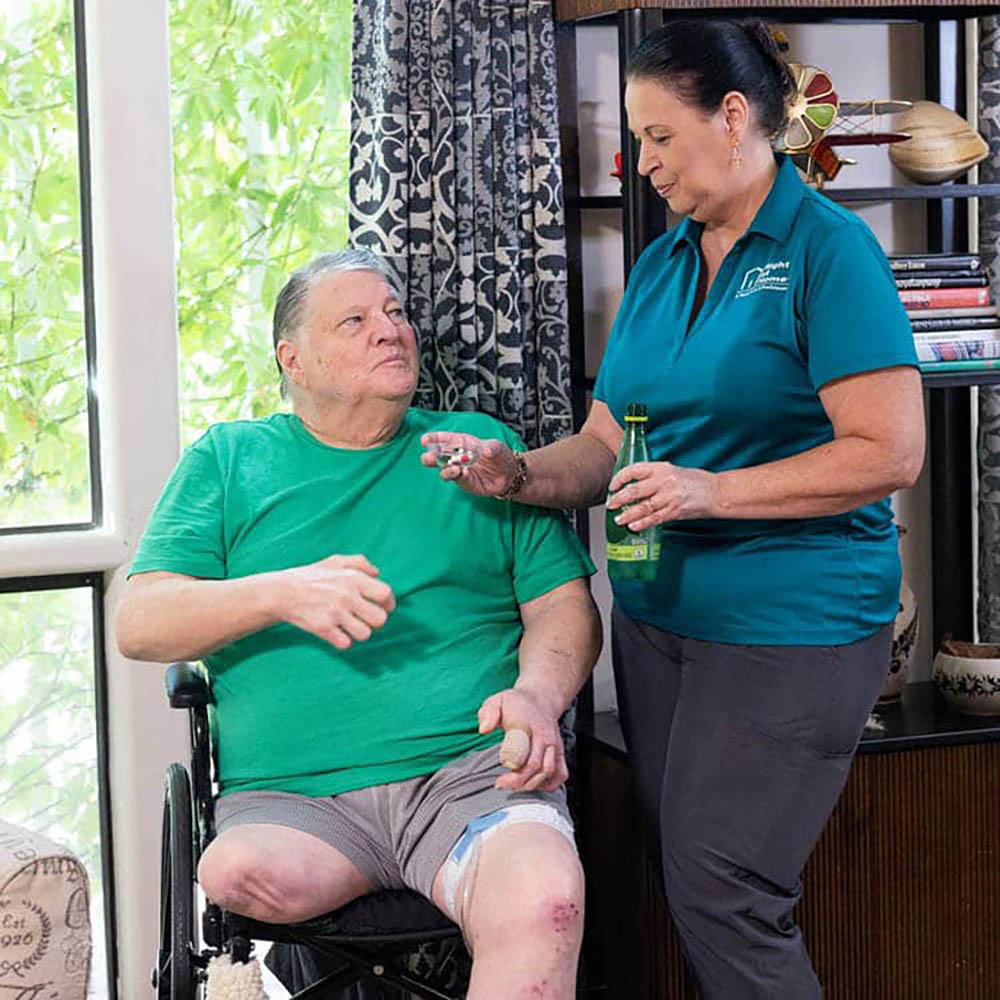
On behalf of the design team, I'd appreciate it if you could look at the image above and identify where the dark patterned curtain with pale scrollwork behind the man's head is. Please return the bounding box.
[350,0,572,447]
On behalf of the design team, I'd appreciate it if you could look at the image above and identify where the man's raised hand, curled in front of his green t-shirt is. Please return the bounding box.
[273,556,396,649]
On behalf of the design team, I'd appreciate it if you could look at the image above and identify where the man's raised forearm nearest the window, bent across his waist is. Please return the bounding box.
[115,573,278,663]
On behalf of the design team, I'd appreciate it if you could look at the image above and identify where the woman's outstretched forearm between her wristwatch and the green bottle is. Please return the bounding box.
[515,431,615,508]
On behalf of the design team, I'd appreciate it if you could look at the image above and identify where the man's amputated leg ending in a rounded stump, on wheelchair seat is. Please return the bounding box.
[198,823,372,924]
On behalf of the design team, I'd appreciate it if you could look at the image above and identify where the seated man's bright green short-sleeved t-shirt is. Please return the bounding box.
[130,409,594,795]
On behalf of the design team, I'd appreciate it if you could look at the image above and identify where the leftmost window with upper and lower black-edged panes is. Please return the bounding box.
[0,0,115,998]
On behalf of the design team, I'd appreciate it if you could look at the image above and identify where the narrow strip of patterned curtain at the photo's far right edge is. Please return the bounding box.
[970,17,1000,642]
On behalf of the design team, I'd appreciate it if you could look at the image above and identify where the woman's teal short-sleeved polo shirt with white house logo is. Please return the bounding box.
[594,155,917,645]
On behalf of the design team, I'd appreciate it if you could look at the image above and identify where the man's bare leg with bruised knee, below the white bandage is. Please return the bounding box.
[432,823,583,1000]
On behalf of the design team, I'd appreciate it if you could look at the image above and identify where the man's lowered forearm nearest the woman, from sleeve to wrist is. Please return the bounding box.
[514,580,601,718]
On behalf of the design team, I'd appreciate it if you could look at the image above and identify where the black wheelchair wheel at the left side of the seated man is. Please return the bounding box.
[153,764,197,1000]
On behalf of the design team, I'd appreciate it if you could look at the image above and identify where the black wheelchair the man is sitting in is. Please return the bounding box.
[152,663,468,1000]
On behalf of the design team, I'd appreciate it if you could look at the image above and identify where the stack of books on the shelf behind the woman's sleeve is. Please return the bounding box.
[889,253,1000,372]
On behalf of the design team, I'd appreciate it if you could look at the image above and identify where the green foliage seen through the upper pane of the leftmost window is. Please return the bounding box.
[0,0,91,528]
